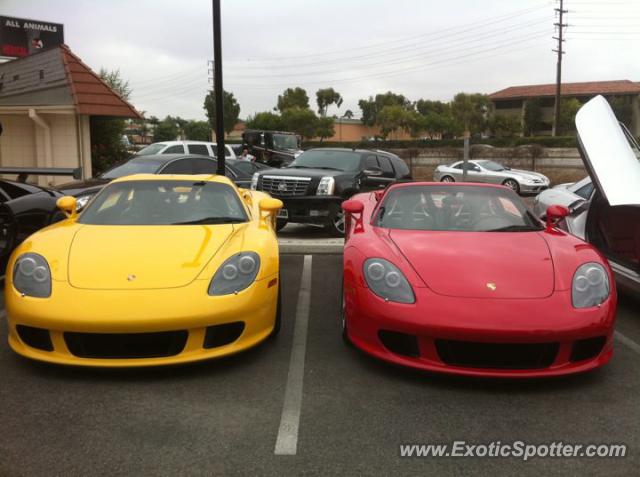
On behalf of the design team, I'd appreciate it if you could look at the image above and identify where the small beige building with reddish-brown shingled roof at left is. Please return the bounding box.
[0,45,141,182]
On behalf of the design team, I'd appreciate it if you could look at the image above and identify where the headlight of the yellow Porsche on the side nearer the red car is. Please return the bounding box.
[209,252,260,295]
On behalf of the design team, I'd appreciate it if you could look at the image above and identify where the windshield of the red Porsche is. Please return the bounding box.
[374,185,542,232]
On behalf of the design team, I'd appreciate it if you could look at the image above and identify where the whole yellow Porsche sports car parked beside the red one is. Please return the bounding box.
[5,175,282,367]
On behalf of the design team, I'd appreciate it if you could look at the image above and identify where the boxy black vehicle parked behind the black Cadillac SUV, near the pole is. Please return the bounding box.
[242,129,303,167]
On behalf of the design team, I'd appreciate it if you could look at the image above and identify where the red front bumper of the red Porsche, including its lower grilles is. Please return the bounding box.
[345,280,616,378]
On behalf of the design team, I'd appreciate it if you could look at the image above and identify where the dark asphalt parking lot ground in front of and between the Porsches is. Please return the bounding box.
[0,251,640,477]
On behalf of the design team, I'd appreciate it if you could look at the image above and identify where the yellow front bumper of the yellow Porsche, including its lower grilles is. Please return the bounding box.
[5,275,279,367]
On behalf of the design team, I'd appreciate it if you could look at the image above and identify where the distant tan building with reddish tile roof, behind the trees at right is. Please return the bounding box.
[489,80,640,136]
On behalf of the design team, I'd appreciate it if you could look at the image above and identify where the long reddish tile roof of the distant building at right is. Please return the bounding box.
[489,80,640,101]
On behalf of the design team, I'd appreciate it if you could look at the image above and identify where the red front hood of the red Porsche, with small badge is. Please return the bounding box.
[390,230,554,298]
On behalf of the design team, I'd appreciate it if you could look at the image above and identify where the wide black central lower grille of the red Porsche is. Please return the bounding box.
[435,340,560,369]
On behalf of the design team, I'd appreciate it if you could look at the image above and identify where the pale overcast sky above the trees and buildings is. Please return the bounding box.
[5,0,640,119]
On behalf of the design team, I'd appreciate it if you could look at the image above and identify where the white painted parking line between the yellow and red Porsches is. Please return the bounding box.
[274,255,312,455]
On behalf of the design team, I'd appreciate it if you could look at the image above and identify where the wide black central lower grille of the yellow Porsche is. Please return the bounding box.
[64,330,189,359]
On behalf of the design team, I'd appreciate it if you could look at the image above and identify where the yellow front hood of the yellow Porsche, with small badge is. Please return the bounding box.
[68,224,233,290]
